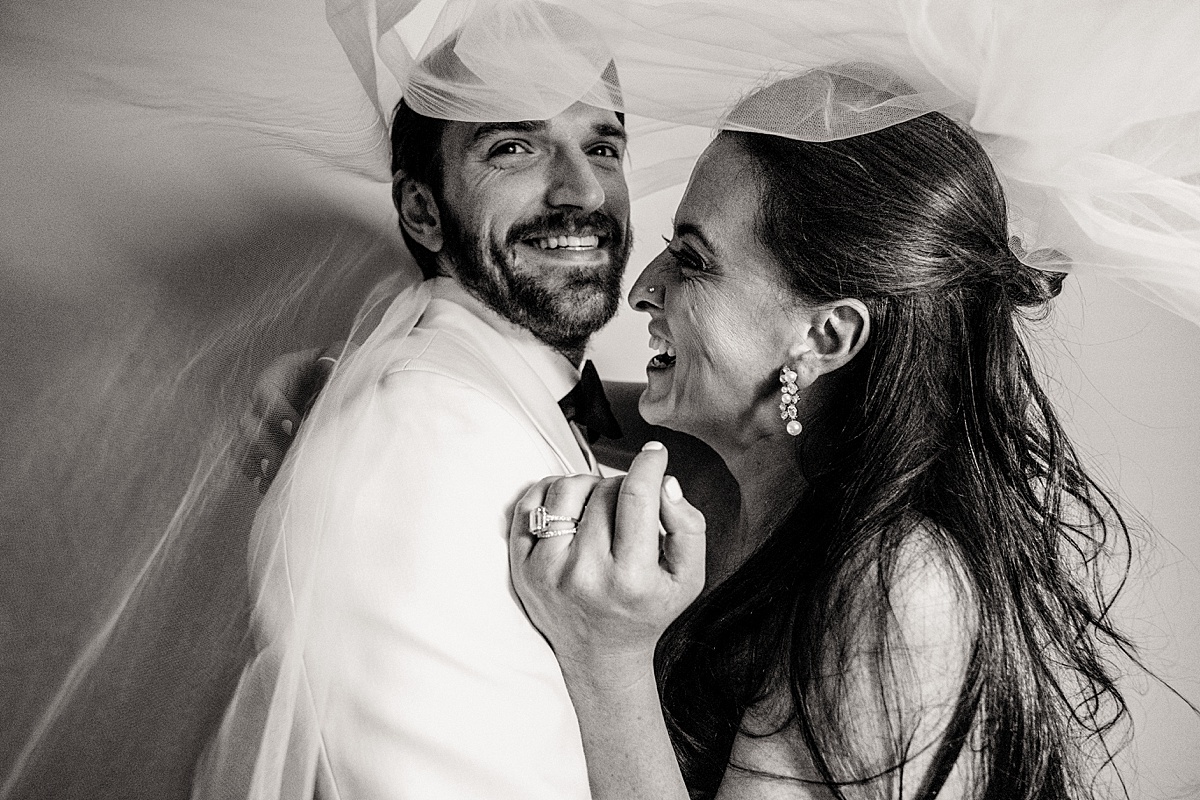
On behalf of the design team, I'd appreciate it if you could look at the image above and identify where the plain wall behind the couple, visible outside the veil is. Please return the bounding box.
[0,0,1200,798]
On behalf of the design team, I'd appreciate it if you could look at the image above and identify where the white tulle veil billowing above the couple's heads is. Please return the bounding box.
[328,0,1200,323]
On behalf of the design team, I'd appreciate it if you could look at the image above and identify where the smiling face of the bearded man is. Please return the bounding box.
[439,103,631,353]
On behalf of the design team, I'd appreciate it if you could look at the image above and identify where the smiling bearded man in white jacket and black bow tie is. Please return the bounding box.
[226,95,630,800]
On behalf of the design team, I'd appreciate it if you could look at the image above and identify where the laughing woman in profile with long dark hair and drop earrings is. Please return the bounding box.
[510,77,1128,799]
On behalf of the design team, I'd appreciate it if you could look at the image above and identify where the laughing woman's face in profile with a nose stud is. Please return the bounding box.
[629,137,797,455]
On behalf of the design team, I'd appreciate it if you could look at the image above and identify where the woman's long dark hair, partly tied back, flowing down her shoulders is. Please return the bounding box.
[659,113,1129,800]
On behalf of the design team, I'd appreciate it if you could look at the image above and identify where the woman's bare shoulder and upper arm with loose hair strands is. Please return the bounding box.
[718,521,978,800]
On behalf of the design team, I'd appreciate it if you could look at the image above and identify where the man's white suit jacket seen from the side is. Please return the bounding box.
[206,278,595,800]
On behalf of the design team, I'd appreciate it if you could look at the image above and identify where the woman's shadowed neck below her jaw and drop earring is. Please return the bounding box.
[706,435,808,588]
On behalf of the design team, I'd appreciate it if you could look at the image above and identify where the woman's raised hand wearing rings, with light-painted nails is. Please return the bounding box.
[509,441,704,684]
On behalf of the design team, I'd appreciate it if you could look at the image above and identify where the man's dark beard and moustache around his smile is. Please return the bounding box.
[442,207,630,353]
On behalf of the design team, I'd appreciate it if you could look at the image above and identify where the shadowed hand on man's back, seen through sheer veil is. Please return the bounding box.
[238,343,344,494]
